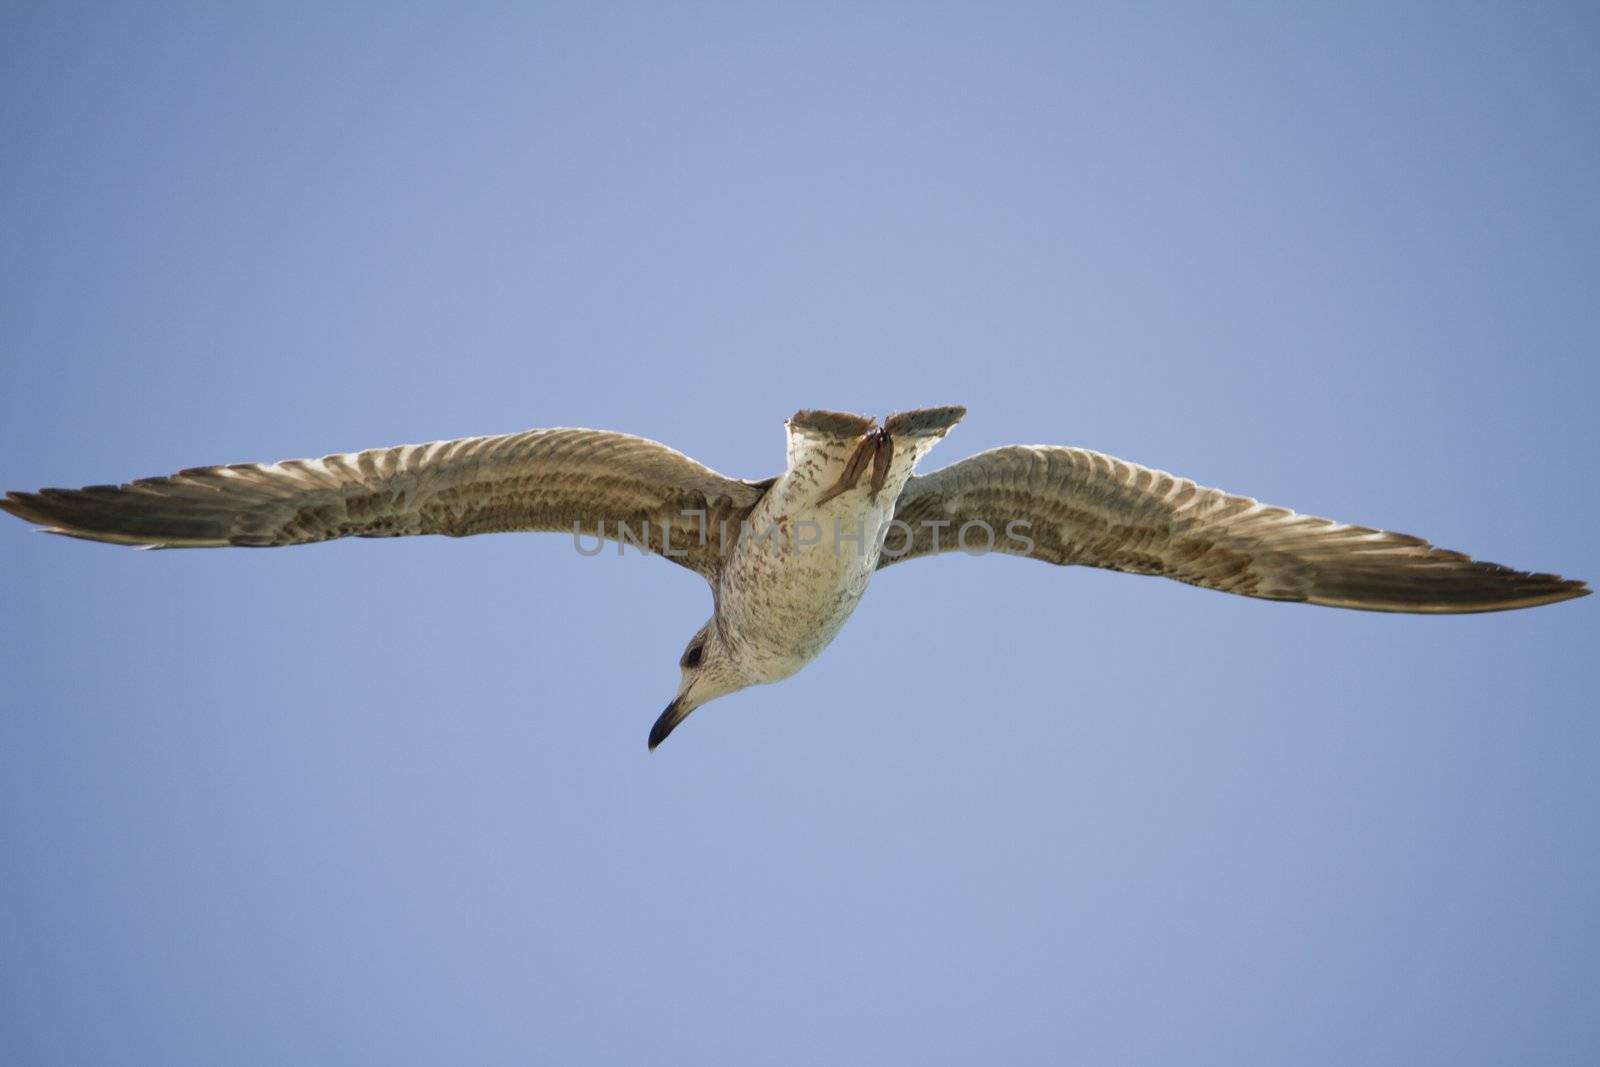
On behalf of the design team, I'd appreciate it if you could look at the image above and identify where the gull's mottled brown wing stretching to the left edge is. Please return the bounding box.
[0,429,763,574]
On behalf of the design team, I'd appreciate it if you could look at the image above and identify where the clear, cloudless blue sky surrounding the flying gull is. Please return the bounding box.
[0,3,1600,1067]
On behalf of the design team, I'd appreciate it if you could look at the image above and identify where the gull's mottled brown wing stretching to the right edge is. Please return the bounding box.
[880,445,1589,613]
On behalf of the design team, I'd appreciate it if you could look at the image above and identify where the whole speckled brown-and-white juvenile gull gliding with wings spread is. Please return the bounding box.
[0,406,1589,749]
